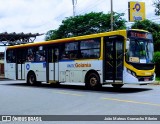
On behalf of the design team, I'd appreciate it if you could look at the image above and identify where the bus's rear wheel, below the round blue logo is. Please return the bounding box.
[27,72,37,85]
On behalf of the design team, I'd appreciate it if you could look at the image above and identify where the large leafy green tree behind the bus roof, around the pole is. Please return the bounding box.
[45,12,126,40]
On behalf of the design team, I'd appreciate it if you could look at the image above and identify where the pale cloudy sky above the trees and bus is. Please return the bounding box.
[0,0,160,49]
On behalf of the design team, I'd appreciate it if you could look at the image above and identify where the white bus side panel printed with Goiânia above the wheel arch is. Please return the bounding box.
[59,60,103,82]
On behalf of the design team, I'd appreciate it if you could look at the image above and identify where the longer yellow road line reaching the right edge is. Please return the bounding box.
[102,98,160,107]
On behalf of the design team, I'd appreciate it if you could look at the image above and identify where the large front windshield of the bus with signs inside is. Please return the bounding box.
[127,38,153,63]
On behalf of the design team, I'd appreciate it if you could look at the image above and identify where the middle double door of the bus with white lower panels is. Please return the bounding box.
[47,48,59,83]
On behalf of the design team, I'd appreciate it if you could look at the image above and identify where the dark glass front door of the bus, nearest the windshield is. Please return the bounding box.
[104,36,124,83]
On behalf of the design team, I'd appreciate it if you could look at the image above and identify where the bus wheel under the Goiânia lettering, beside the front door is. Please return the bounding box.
[85,73,102,89]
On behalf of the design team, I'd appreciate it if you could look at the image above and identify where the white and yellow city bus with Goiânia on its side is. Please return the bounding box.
[5,29,155,89]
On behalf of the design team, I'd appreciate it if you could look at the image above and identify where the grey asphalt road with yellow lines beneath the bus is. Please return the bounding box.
[0,80,160,123]
